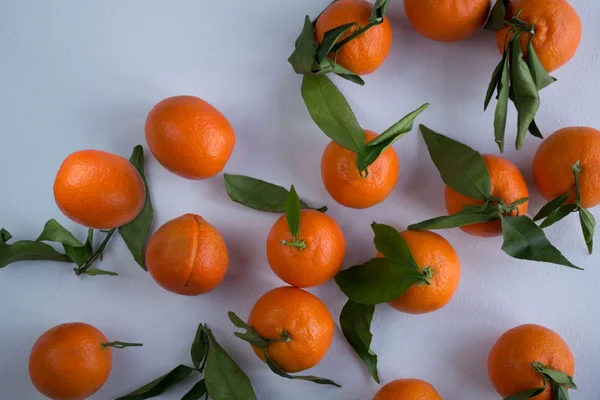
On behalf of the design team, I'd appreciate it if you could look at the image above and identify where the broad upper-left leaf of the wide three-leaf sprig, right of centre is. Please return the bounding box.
[420,125,491,200]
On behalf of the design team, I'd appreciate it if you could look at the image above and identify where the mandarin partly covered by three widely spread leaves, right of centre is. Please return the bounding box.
[446,154,529,237]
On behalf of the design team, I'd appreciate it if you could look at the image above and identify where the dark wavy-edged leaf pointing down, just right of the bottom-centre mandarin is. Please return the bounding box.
[340,300,380,383]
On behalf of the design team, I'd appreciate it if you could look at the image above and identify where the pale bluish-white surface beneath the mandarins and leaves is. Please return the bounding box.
[0,0,600,400]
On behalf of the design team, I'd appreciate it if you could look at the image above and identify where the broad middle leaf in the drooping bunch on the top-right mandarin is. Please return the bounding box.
[510,34,540,150]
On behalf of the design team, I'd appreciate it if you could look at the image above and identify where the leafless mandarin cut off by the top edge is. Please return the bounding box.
[404,0,490,42]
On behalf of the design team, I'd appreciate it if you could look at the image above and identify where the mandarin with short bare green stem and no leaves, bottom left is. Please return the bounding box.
[29,322,112,400]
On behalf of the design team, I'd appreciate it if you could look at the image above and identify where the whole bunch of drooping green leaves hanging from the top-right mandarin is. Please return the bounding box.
[484,7,556,152]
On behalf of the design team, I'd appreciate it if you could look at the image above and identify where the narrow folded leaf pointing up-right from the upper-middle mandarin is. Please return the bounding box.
[356,103,429,176]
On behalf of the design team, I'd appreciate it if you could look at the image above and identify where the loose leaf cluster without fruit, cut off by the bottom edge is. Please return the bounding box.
[117,324,256,400]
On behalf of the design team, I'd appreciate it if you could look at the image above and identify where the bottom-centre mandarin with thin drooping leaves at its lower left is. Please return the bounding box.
[248,286,334,373]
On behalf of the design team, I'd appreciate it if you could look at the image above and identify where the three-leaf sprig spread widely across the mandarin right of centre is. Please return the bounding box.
[408,125,581,269]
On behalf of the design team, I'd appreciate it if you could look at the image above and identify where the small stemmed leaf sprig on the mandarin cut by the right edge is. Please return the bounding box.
[533,162,596,254]
